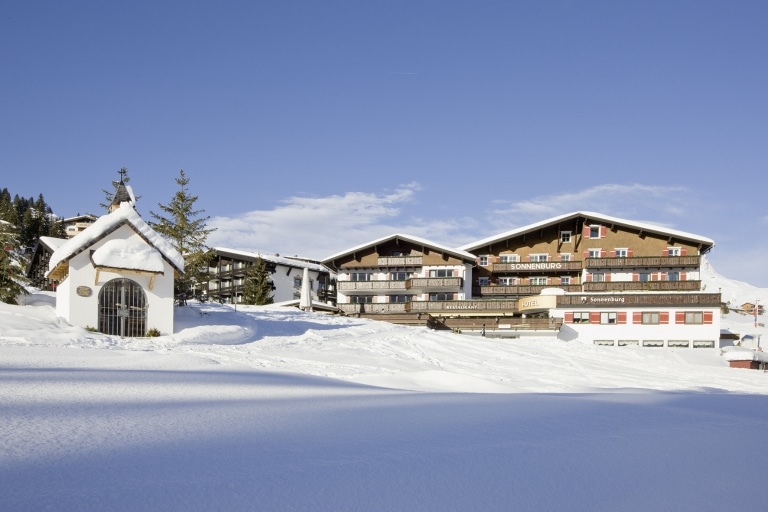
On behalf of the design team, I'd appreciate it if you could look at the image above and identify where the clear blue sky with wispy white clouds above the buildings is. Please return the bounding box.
[0,0,768,287]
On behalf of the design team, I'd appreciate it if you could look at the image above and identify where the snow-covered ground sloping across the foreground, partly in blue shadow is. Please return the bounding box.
[0,258,768,512]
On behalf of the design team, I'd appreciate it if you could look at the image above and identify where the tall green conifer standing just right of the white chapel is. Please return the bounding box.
[149,170,215,295]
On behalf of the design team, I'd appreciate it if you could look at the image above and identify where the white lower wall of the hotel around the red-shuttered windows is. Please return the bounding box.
[550,307,720,348]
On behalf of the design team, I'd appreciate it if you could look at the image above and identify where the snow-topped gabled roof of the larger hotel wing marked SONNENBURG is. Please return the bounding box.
[460,211,715,254]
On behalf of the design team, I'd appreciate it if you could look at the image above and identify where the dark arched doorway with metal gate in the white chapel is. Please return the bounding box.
[99,278,147,337]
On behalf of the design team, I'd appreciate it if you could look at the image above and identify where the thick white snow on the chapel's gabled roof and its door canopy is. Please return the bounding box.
[47,202,184,275]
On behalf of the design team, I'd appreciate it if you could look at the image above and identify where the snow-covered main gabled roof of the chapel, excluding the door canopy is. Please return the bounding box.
[46,202,184,276]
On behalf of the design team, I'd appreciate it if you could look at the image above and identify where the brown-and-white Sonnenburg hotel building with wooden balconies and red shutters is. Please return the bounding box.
[323,212,721,348]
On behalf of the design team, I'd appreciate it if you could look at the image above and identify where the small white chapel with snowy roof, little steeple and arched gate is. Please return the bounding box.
[46,180,184,336]
